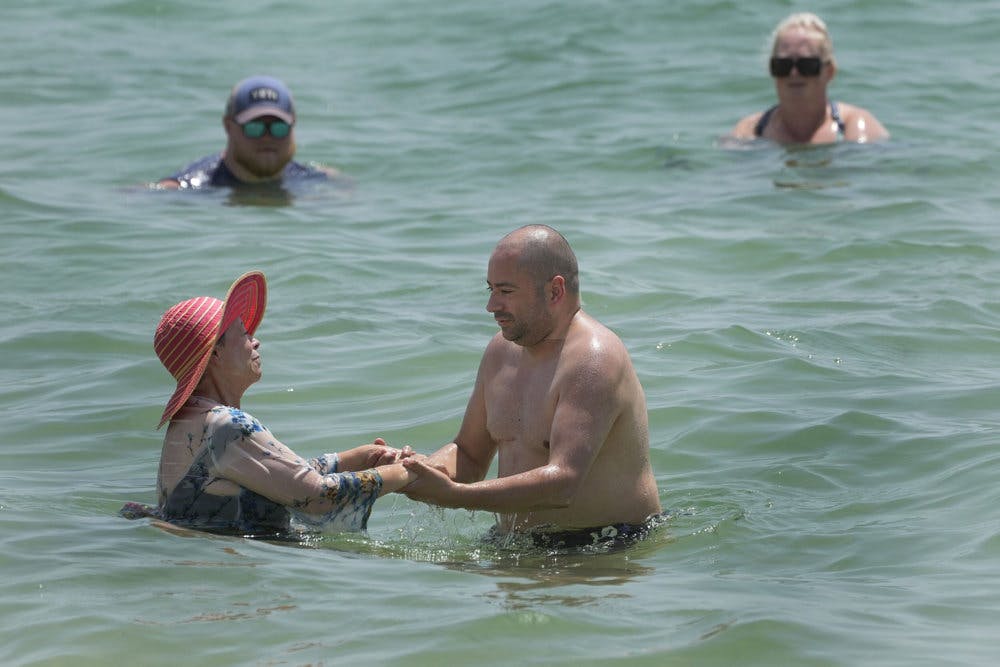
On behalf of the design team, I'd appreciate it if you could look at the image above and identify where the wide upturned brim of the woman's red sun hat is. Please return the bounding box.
[156,271,267,429]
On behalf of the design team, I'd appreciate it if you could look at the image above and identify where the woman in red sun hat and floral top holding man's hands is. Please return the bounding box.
[122,271,416,536]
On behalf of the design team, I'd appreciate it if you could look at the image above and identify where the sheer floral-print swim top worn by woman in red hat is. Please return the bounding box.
[155,406,382,535]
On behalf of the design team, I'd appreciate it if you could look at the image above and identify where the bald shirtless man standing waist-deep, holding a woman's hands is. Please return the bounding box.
[404,225,661,547]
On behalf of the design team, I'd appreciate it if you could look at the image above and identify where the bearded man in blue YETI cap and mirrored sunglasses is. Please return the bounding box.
[156,76,337,190]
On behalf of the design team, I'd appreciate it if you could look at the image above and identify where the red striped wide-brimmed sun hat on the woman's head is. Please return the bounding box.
[153,271,267,428]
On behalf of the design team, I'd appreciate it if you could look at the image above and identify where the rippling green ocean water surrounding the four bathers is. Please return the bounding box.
[0,0,1000,667]
